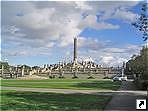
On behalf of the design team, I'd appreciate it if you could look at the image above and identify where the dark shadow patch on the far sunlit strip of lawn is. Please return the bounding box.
[73,81,121,90]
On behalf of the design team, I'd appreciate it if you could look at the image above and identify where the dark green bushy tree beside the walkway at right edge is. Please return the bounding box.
[126,47,148,89]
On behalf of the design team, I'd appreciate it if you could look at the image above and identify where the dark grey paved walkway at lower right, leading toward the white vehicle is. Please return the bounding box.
[106,81,147,111]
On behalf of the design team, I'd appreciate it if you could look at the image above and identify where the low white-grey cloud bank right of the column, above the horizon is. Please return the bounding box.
[78,44,141,66]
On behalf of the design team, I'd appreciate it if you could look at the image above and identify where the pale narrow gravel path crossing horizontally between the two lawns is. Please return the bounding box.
[1,86,147,96]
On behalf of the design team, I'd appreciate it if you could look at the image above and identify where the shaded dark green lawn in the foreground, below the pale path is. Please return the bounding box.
[0,90,111,111]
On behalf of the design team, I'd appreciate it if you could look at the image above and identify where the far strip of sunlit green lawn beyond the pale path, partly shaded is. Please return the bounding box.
[1,79,121,90]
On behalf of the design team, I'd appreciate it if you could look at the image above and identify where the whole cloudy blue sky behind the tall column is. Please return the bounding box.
[1,1,143,66]
